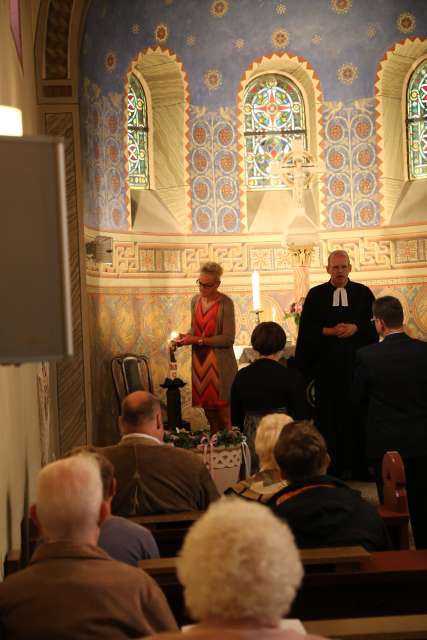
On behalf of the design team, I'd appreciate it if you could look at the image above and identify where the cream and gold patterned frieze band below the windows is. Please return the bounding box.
[86,225,427,280]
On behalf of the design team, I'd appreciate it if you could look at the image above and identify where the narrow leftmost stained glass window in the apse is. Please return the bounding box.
[128,74,150,189]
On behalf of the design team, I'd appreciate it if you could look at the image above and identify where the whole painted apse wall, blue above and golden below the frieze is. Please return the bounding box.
[80,0,427,441]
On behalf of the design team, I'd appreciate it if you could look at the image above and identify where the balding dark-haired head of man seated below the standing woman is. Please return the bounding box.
[119,391,163,440]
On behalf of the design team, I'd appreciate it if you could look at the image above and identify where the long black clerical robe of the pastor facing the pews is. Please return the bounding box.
[295,280,378,474]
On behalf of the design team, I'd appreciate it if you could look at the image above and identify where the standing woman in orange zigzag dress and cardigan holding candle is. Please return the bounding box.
[175,262,237,432]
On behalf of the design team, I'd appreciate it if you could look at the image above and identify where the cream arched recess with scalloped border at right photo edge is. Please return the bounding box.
[374,37,427,224]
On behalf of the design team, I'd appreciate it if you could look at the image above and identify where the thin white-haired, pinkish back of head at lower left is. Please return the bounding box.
[36,455,102,542]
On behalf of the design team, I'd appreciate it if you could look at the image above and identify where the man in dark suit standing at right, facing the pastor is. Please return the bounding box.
[353,296,427,548]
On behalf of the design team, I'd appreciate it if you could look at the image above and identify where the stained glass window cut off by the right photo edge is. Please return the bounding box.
[406,60,427,180]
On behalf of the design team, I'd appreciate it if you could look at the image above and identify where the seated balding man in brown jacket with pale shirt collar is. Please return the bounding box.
[100,391,218,516]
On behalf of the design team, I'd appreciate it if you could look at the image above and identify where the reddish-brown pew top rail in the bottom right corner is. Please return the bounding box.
[304,615,427,640]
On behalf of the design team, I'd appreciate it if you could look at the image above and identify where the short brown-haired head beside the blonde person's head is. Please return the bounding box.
[274,420,328,482]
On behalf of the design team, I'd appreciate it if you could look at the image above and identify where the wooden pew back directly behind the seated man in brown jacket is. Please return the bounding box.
[129,511,204,558]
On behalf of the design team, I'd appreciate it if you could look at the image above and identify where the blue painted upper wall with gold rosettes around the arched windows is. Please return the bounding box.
[81,0,427,233]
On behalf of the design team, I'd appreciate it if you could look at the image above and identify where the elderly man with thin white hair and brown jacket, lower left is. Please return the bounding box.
[0,454,176,640]
